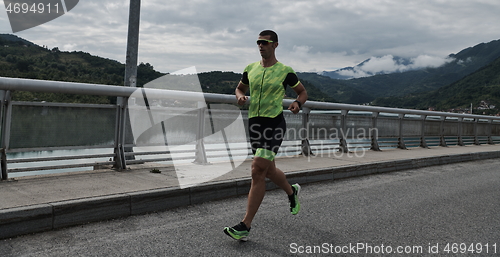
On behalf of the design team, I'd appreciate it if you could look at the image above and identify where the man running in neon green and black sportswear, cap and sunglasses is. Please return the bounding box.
[224,30,307,241]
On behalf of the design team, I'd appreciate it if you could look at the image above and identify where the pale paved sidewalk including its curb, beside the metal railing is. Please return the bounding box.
[0,145,500,238]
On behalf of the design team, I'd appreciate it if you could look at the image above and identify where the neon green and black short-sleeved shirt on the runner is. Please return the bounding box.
[241,61,299,118]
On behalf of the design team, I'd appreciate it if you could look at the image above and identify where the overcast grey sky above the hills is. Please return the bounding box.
[0,0,500,73]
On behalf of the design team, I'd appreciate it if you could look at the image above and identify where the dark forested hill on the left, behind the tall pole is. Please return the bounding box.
[0,34,336,103]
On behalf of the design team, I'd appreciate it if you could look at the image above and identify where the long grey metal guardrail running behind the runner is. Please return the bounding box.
[0,77,500,180]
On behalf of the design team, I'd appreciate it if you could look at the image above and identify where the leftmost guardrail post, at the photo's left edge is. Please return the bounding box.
[0,90,12,180]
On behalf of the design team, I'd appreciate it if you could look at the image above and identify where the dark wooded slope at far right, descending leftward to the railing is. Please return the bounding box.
[374,55,500,114]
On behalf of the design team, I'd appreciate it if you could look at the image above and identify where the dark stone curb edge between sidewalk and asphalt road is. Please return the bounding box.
[0,151,500,239]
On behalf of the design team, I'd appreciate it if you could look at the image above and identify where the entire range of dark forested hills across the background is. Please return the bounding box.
[0,34,500,113]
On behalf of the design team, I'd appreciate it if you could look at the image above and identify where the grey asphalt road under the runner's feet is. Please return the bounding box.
[0,160,500,257]
